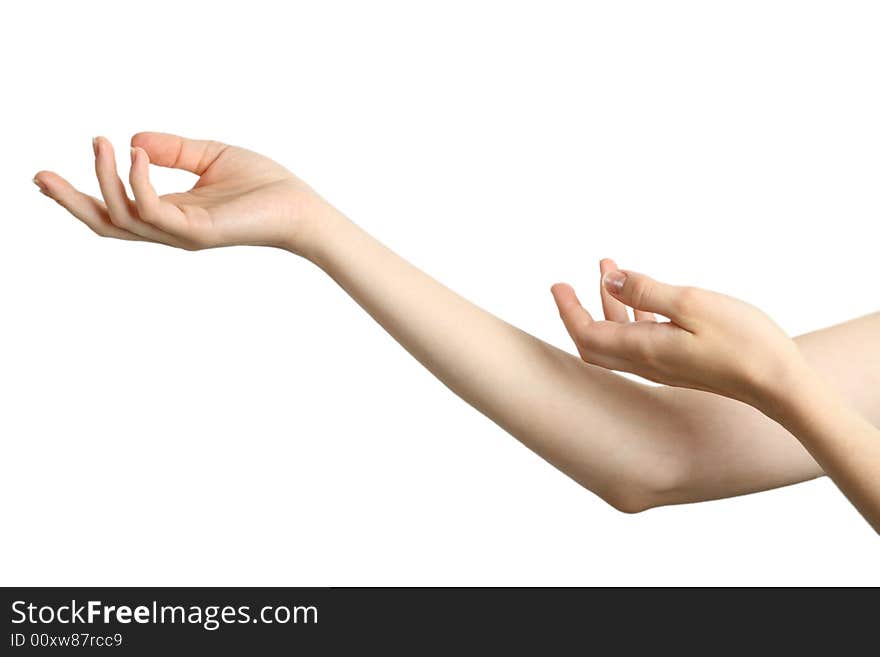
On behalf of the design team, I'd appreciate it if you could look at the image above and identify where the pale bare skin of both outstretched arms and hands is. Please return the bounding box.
[34,133,880,528]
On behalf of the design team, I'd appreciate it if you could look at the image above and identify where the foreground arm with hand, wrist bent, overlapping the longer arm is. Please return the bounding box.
[554,269,880,531]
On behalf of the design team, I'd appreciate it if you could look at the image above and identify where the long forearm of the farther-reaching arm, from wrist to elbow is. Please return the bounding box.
[307,212,675,499]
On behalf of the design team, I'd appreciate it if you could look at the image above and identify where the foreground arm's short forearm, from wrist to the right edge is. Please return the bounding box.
[761,364,880,532]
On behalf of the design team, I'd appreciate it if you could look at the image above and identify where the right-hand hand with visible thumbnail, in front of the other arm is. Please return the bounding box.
[552,260,805,405]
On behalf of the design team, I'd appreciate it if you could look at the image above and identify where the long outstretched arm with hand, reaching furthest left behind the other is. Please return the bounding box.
[36,133,880,511]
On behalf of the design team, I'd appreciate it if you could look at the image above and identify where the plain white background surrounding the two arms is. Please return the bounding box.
[0,1,880,585]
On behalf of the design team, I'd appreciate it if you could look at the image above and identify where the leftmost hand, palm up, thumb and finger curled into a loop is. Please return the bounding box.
[34,132,328,253]
